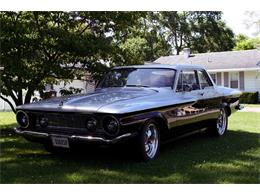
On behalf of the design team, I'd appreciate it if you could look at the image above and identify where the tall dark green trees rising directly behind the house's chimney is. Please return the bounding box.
[157,11,234,55]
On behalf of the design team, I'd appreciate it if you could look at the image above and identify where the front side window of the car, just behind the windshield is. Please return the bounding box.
[176,70,200,92]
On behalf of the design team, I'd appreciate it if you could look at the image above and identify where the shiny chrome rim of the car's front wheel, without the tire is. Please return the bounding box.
[144,124,158,158]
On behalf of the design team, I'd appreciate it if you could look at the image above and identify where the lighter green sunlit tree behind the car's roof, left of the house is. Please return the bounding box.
[115,12,171,64]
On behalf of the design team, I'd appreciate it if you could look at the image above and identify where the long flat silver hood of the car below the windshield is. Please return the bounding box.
[17,87,158,112]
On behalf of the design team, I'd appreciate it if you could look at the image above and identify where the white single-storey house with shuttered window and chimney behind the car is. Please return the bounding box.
[154,48,260,98]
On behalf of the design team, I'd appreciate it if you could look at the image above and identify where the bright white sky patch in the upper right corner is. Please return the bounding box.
[223,10,259,37]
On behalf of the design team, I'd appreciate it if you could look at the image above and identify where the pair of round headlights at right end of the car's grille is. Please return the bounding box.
[86,116,119,136]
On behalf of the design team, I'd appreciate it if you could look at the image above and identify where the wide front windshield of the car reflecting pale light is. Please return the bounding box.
[98,68,175,88]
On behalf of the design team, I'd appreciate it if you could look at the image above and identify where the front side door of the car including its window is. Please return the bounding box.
[171,69,206,135]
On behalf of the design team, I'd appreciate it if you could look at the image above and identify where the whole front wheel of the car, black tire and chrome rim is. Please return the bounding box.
[138,120,160,161]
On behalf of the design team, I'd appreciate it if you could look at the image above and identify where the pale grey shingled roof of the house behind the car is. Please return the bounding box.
[154,49,260,72]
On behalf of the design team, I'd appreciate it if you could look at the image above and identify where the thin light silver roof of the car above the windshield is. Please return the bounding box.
[113,64,204,70]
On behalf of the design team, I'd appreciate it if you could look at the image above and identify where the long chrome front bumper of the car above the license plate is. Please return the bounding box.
[14,128,135,144]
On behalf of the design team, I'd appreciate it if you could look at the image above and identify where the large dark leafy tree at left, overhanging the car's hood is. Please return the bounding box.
[0,12,140,112]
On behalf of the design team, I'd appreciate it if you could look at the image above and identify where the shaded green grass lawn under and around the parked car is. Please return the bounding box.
[0,112,260,183]
